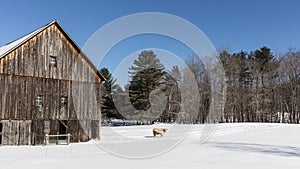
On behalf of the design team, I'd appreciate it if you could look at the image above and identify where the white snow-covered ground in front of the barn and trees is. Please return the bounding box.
[0,123,300,169]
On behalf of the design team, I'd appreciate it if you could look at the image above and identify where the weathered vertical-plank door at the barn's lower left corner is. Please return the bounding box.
[2,120,31,145]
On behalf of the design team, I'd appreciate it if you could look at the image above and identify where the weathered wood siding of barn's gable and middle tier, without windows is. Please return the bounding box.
[0,24,101,120]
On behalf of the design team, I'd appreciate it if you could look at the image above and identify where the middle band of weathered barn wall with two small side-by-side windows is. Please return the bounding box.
[0,75,101,120]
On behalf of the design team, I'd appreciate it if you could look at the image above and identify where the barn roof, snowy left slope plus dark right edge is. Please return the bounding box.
[0,20,105,80]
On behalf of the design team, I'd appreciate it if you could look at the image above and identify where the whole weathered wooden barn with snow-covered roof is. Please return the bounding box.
[0,21,104,145]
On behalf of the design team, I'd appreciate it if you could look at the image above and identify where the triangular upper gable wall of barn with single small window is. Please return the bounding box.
[0,24,101,82]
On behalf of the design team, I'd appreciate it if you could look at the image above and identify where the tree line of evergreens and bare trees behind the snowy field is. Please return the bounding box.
[100,47,300,123]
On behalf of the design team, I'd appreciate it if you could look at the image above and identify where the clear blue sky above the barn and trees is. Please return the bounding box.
[0,0,300,86]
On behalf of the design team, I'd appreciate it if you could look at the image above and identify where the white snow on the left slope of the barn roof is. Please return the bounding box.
[0,21,57,58]
